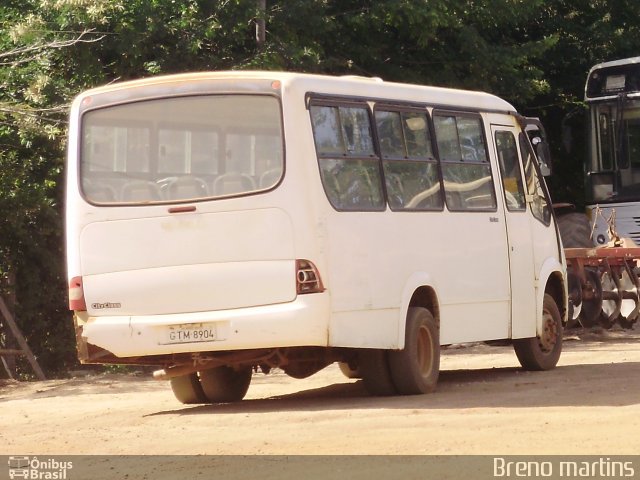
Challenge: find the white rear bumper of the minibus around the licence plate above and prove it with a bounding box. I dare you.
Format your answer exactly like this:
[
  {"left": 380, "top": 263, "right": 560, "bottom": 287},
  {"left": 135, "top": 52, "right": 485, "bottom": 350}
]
[{"left": 75, "top": 292, "right": 330, "bottom": 363}]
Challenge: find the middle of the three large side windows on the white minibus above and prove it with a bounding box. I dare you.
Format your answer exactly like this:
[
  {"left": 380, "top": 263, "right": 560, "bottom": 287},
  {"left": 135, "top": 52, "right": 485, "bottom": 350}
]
[{"left": 375, "top": 110, "right": 443, "bottom": 210}]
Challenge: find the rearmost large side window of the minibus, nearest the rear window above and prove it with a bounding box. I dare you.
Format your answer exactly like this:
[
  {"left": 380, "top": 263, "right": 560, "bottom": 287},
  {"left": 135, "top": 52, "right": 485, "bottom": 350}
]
[{"left": 310, "top": 105, "right": 385, "bottom": 211}]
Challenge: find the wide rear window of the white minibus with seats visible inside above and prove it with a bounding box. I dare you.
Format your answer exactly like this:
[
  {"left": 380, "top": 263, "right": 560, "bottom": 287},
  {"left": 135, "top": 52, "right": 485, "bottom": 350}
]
[{"left": 80, "top": 95, "right": 284, "bottom": 204}]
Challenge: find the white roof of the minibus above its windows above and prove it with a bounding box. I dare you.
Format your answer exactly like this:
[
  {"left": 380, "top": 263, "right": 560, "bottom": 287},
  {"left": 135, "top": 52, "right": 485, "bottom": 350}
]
[{"left": 75, "top": 70, "right": 516, "bottom": 113}]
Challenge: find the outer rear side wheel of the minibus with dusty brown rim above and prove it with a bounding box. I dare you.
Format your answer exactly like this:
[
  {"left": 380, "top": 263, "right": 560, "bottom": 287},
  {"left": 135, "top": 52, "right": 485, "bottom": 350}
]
[{"left": 389, "top": 307, "right": 440, "bottom": 395}]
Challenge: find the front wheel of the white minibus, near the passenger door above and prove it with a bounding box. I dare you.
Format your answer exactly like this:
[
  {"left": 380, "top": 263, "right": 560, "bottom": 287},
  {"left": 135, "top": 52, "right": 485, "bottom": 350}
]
[{"left": 513, "top": 293, "right": 562, "bottom": 371}]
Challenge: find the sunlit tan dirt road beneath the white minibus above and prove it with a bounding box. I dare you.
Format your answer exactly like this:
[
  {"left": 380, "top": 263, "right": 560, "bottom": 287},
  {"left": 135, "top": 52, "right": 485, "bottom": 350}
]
[{"left": 0, "top": 331, "right": 640, "bottom": 455}]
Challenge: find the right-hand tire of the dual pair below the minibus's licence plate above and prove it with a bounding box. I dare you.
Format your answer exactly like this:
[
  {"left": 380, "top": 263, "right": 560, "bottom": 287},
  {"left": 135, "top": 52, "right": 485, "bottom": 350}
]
[{"left": 199, "top": 366, "right": 252, "bottom": 403}]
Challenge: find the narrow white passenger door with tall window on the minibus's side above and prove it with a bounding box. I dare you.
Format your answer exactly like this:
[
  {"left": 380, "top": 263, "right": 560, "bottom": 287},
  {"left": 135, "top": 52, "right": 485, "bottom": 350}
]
[{"left": 491, "top": 124, "right": 537, "bottom": 338}]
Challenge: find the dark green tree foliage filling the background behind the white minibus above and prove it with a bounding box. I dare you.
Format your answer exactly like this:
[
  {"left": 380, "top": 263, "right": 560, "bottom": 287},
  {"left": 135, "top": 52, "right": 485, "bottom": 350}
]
[{"left": 0, "top": 0, "right": 640, "bottom": 372}]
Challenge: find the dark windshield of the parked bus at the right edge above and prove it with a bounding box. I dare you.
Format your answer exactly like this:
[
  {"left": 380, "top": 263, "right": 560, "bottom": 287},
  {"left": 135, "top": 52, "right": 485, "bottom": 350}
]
[{"left": 589, "top": 102, "right": 640, "bottom": 202}]
